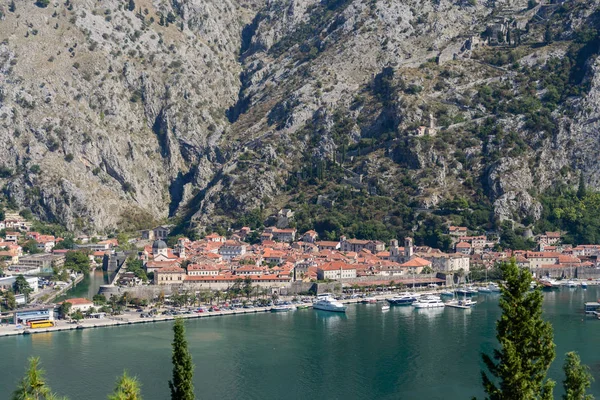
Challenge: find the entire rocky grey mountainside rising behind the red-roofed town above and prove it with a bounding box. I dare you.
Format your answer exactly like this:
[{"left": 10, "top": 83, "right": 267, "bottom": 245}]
[{"left": 0, "top": 0, "right": 600, "bottom": 239}]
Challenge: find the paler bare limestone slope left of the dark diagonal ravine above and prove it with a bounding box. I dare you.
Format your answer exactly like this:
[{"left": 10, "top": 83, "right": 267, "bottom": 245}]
[{"left": 0, "top": 0, "right": 251, "bottom": 229}]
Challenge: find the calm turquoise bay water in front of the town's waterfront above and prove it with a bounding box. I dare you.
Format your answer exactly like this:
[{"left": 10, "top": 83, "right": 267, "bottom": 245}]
[{"left": 0, "top": 288, "right": 600, "bottom": 400}]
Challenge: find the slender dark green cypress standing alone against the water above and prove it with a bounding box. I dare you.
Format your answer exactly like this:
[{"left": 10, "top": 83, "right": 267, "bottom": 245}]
[{"left": 169, "top": 318, "right": 194, "bottom": 400}]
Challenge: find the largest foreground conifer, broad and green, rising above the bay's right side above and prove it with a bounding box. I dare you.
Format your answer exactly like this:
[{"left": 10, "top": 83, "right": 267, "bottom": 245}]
[{"left": 481, "top": 259, "right": 555, "bottom": 400}]
